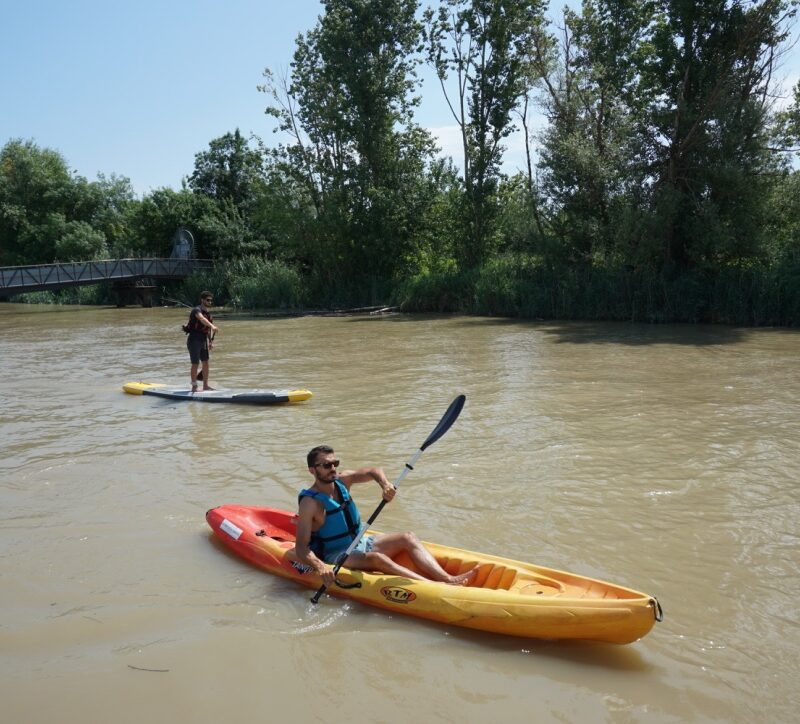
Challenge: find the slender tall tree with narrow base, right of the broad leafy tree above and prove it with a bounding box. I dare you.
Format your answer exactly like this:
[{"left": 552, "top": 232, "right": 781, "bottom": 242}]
[{"left": 425, "top": 0, "right": 545, "bottom": 267}]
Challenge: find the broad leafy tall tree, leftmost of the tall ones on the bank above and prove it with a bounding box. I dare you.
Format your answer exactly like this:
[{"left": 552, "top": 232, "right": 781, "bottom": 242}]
[{"left": 262, "top": 0, "right": 433, "bottom": 294}]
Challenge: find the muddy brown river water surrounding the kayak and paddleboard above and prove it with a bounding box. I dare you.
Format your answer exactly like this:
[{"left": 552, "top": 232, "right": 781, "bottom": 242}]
[{"left": 0, "top": 304, "right": 800, "bottom": 724}]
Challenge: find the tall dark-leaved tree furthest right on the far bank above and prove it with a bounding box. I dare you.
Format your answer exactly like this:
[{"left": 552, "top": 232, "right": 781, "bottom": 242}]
[{"left": 641, "top": 0, "right": 795, "bottom": 269}]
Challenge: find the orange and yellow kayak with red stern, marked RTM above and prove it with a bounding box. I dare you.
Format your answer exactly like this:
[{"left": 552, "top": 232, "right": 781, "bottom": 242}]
[{"left": 206, "top": 505, "right": 662, "bottom": 644}]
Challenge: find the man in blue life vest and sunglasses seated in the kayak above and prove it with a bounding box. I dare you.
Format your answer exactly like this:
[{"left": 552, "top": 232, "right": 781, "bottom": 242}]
[{"left": 295, "top": 445, "right": 478, "bottom": 586}]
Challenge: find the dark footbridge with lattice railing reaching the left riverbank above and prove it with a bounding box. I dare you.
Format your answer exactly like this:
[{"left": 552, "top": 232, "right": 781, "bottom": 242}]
[{"left": 0, "top": 259, "right": 214, "bottom": 296}]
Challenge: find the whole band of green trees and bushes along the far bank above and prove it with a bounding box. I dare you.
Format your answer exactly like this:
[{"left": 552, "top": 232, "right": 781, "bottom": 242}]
[{"left": 0, "top": 0, "right": 800, "bottom": 325}]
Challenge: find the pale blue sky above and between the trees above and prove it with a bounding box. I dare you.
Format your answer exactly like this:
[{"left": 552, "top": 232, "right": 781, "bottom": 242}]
[{"left": 0, "top": 0, "right": 800, "bottom": 195}]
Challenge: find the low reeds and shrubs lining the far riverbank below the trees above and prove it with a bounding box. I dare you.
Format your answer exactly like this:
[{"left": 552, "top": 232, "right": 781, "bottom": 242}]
[{"left": 12, "top": 252, "right": 800, "bottom": 327}]
